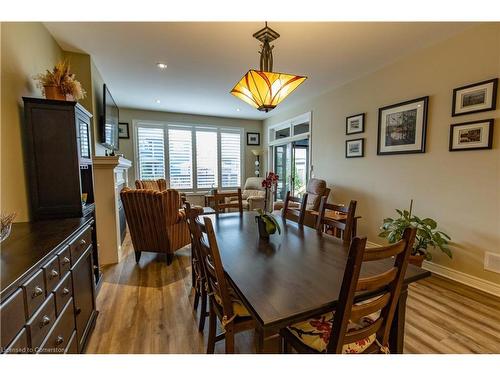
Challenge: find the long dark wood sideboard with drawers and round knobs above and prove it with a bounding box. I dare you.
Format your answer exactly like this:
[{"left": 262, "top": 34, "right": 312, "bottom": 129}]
[{"left": 0, "top": 217, "right": 98, "bottom": 354}]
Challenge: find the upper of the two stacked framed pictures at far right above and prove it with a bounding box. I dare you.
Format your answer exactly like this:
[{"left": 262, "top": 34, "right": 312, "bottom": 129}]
[{"left": 451, "top": 78, "right": 498, "bottom": 117}]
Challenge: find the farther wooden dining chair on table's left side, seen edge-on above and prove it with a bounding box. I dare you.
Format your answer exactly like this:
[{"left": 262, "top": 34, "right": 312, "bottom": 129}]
[{"left": 184, "top": 201, "right": 208, "bottom": 332}]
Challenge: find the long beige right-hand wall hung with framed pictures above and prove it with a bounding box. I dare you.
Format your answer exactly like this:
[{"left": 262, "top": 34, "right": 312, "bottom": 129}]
[{"left": 264, "top": 23, "right": 500, "bottom": 283}]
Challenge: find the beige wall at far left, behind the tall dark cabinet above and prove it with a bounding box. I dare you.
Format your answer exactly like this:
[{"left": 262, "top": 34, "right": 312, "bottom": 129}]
[{"left": 0, "top": 22, "right": 62, "bottom": 221}]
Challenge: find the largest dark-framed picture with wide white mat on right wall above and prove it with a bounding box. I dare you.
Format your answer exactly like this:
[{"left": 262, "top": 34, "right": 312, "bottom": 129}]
[{"left": 377, "top": 96, "right": 429, "bottom": 155}]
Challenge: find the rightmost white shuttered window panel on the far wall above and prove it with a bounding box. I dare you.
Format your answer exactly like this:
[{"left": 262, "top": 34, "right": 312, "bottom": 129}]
[{"left": 220, "top": 133, "right": 241, "bottom": 188}]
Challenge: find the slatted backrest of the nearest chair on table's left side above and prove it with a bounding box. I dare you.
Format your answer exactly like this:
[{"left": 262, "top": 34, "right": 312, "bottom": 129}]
[{"left": 195, "top": 217, "right": 233, "bottom": 319}]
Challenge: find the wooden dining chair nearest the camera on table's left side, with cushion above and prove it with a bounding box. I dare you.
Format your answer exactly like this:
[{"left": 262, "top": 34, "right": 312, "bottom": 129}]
[{"left": 195, "top": 217, "right": 255, "bottom": 354}]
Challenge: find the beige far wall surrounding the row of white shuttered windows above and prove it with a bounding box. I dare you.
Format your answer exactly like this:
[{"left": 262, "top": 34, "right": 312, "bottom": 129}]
[{"left": 118, "top": 108, "right": 262, "bottom": 188}]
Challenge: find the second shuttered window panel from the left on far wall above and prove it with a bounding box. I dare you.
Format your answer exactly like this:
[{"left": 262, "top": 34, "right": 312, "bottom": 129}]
[{"left": 168, "top": 129, "right": 193, "bottom": 189}]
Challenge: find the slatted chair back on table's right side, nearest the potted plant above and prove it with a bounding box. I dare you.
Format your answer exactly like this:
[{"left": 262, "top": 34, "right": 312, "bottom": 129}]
[{"left": 316, "top": 197, "right": 357, "bottom": 242}]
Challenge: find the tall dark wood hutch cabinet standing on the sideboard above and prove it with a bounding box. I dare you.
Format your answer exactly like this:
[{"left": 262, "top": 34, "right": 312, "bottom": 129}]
[{"left": 23, "top": 98, "right": 94, "bottom": 220}]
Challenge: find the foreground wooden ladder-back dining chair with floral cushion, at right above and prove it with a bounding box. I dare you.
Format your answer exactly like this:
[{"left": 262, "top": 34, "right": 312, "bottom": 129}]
[{"left": 280, "top": 228, "right": 416, "bottom": 354}]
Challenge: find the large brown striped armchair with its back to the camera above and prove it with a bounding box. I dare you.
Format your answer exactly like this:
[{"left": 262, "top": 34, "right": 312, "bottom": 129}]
[{"left": 120, "top": 188, "right": 191, "bottom": 264}]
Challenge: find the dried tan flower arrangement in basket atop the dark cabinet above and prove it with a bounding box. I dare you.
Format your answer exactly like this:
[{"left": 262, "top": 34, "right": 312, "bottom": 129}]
[{"left": 34, "top": 60, "right": 86, "bottom": 101}]
